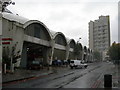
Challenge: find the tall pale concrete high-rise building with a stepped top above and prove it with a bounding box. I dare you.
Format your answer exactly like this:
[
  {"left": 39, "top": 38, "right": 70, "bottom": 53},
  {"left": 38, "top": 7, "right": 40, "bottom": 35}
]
[{"left": 89, "top": 16, "right": 110, "bottom": 60}]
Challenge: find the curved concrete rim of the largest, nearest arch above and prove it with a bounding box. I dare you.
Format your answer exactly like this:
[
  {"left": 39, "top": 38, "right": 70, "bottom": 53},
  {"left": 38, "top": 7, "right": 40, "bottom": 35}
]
[{"left": 23, "top": 20, "right": 52, "bottom": 39}]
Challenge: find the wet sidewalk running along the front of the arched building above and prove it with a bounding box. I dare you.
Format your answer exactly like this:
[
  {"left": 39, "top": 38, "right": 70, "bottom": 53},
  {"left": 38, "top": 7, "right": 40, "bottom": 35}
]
[{"left": 2, "top": 67, "right": 68, "bottom": 83}]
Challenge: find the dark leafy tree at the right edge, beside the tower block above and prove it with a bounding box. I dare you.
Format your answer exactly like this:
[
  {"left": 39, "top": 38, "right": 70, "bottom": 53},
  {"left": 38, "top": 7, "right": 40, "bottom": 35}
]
[{"left": 108, "top": 42, "right": 120, "bottom": 64}]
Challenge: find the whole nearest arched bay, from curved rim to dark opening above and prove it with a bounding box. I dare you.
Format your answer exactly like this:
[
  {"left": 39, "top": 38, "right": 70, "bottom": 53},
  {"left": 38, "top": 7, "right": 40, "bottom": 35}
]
[{"left": 21, "top": 20, "right": 52, "bottom": 67}]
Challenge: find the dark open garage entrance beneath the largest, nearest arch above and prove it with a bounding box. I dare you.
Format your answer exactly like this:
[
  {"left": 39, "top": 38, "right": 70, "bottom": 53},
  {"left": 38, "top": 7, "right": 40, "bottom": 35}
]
[{"left": 21, "top": 42, "right": 50, "bottom": 69}]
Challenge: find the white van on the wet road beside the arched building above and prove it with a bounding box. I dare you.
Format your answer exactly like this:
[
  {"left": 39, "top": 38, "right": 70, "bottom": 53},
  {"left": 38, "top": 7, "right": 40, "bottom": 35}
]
[{"left": 70, "top": 60, "right": 88, "bottom": 69}]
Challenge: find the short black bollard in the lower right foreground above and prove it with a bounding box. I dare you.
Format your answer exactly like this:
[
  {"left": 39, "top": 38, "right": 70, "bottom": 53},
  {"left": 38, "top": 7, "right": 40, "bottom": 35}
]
[{"left": 104, "top": 74, "right": 112, "bottom": 88}]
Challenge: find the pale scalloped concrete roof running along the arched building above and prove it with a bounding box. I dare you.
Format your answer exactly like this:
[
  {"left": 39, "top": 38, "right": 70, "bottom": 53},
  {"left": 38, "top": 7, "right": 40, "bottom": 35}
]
[{"left": 2, "top": 12, "right": 82, "bottom": 46}]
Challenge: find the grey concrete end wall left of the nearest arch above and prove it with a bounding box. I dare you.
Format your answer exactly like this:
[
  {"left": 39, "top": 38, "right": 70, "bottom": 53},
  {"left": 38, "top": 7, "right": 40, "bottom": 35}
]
[{"left": 3, "top": 18, "right": 24, "bottom": 66}]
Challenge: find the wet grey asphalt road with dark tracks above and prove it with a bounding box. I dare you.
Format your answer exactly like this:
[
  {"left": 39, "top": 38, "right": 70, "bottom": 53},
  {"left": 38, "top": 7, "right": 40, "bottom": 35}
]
[{"left": 3, "top": 62, "right": 113, "bottom": 88}]
